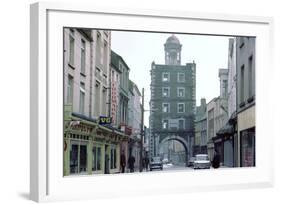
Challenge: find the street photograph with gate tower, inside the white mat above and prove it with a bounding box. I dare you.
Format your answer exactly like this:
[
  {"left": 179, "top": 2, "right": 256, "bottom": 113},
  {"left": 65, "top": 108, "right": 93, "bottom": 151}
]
[{"left": 63, "top": 28, "right": 256, "bottom": 176}]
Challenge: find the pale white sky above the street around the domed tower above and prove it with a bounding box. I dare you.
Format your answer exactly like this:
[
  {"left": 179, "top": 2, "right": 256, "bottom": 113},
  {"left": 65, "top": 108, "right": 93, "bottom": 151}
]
[{"left": 111, "top": 31, "right": 230, "bottom": 127}]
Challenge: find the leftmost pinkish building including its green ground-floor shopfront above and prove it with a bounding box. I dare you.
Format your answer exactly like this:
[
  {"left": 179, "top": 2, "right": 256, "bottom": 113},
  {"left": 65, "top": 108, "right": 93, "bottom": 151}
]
[{"left": 63, "top": 28, "right": 128, "bottom": 176}]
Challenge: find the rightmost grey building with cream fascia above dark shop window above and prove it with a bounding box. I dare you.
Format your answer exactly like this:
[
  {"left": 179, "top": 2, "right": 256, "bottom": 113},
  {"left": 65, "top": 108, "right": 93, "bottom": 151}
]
[{"left": 236, "top": 37, "right": 256, "bottom": 167}]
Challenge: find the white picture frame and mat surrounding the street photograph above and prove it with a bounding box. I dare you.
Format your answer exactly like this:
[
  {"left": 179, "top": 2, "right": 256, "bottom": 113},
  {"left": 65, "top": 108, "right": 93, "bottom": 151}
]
[{"left": 30, "top": 2, "right": 274, "bottom": 202}]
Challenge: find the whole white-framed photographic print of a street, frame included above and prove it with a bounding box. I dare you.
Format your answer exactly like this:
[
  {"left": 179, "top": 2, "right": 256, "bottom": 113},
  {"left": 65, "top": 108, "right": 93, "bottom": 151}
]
[{"left": 30, "top": 3, "right": 273, "bottom": 201}]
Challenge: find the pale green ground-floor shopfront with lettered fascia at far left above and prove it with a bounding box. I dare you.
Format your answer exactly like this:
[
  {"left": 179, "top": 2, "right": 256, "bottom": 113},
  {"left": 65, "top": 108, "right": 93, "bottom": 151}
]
[{"left": 63, "top": 114, "right": 128, "bottom": 176}]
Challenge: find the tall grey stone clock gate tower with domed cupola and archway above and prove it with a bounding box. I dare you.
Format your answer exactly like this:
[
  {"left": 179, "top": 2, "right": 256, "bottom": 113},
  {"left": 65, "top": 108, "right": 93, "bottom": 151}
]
[{"left": 150, "top": 35, "right": 196, "bottom": 163}]
